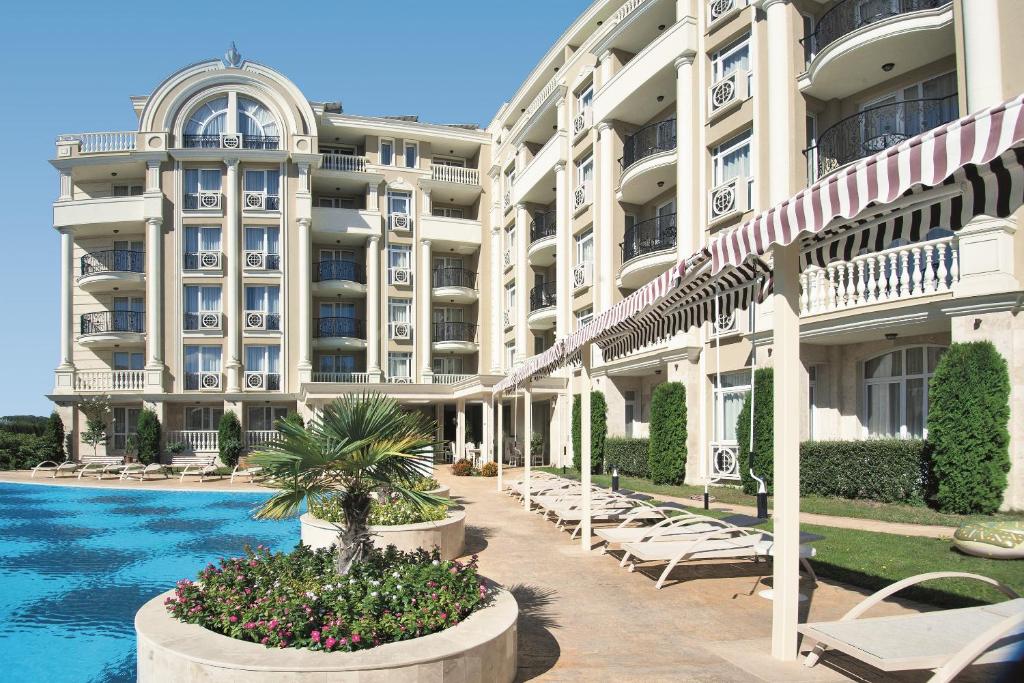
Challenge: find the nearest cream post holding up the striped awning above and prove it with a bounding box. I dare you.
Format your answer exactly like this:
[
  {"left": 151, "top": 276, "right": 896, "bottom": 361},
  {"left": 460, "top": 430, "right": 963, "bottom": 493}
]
[{"left": 771, "top": 242, "right": 803, "bottom": 660}]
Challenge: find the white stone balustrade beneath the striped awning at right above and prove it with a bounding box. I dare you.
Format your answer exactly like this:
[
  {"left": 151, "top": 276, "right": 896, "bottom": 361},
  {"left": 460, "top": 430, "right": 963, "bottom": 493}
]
[{"left": 800, "top": 237, "right": 959, "bottom": 315}]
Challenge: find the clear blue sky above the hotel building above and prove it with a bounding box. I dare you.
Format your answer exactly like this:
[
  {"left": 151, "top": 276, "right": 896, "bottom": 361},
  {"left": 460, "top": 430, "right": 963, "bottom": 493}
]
[{"left": 0, "top": 0, "right": 588, "bottom": 415}]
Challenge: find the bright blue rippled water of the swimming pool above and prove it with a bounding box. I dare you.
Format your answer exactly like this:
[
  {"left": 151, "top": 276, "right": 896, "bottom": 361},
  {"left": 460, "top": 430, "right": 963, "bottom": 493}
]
[{"left": 0, "top": 483, "right": 299, "bottom": 683}]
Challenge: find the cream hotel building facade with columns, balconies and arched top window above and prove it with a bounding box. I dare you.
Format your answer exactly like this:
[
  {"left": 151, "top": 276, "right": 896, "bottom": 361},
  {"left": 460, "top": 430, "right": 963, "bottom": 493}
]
[{"left": 53, "top": 0, "right": 1024, "bottom": 508}]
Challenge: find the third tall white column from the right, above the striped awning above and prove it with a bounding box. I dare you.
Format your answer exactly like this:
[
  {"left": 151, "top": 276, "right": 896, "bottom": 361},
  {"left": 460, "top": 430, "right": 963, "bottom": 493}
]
[{"left": 676, "top": 50, "right": 699, "bottom": 259}]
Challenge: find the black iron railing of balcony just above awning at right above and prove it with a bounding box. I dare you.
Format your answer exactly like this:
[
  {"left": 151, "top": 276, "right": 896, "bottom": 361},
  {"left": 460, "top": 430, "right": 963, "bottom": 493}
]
[{"left": 804, "top": 93, "right": 959, "bottom": 179}]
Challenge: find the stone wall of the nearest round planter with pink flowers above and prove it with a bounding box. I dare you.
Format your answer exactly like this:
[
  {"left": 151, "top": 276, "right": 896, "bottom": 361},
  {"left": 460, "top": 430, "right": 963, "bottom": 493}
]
[{"left": 135, "top": 588, "right": 519, "bottom": 683}]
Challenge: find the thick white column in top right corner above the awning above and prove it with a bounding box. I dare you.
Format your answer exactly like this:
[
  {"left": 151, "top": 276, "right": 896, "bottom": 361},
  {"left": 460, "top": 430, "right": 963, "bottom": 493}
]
[{"left": 961, "top": 0, "right": 1003, "bottom": 113}]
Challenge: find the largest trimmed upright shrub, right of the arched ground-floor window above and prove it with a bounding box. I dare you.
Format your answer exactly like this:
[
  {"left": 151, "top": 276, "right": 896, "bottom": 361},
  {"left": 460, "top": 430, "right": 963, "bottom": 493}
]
[{"left": 928, "top": 341, "right": 1010, "bottom": 514}]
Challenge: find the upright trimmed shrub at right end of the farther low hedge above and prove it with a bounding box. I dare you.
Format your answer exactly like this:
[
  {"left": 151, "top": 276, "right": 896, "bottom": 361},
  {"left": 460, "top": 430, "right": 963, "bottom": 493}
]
[{"left": 648, "top": 382, "right": 686, "bottom": 485}]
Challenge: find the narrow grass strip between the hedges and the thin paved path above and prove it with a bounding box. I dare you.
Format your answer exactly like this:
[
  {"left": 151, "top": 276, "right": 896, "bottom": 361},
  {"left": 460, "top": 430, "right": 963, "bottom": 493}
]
[{"left": 541, "top": 467, "right": 1024, "bottom": 526}]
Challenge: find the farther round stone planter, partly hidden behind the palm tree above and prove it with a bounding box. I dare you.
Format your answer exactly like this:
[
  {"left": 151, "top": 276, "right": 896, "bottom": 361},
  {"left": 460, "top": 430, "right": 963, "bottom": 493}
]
[{"left": 299, "top": 509, "right": 466, "bottom": 560}]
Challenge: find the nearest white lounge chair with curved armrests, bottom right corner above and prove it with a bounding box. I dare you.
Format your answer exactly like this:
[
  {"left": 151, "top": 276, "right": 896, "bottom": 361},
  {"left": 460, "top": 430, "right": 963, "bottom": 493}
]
[{"left": 797, "top": 571, "right": 1024, "bottom": 683}]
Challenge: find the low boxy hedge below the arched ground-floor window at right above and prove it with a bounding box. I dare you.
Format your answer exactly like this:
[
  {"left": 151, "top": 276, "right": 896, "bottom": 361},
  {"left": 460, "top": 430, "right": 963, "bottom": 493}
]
[{"left": 800, "top": 438, "right": 928, "bottom": 505}]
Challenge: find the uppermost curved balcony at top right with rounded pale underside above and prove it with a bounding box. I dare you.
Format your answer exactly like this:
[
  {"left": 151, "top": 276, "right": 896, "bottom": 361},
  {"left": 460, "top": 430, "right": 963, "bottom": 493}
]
[{"left": 799, "top": 0, "right": 956, "bottom": 100}]
